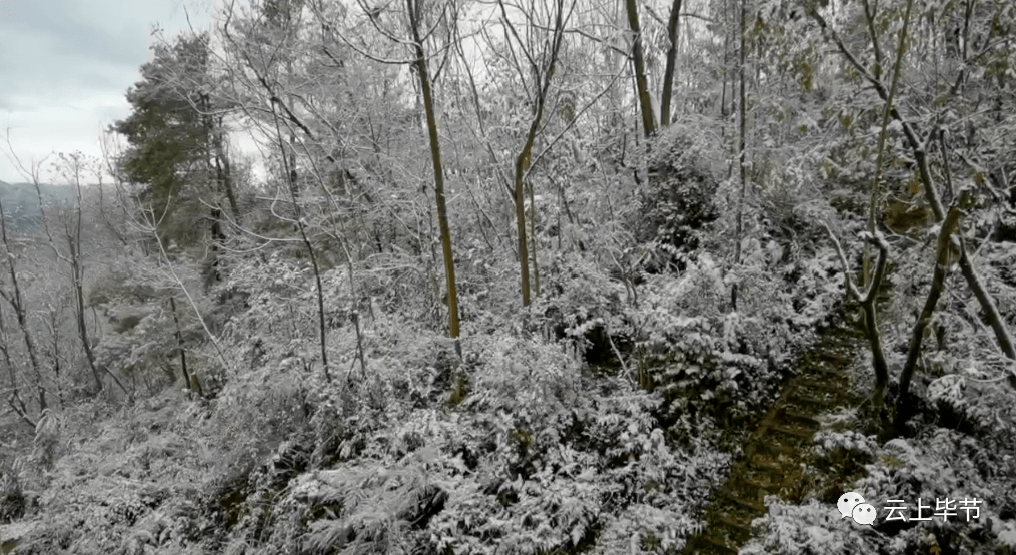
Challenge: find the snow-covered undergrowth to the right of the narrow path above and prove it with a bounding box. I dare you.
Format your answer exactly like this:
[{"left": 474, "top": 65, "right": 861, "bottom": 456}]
[{"left": 741, "top": 222, "right": 1016, "bottom": 555}]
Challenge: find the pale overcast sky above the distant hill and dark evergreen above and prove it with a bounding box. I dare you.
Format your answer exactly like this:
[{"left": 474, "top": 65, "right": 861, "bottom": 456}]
[{"left": 0, "top": 0, "right": 220, "bottom": 183}]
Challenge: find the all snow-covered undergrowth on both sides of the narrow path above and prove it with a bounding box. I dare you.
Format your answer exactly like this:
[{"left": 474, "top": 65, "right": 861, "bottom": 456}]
[{"left": 0, "top": 118, "right": 1016, "bottom": 555}]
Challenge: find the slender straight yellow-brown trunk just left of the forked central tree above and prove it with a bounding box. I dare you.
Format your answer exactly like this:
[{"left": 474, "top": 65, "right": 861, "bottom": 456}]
[{"left": 405, "top": 0, "right": 463, "bottom": 339}]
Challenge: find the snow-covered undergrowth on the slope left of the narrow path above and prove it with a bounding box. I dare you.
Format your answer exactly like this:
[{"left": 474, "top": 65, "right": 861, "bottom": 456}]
[{"left": 4, "top": 126, "right": 842, "bottom": 555}]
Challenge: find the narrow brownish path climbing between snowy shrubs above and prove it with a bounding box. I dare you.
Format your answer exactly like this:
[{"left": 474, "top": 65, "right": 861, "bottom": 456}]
[{"left": 683, "top": 323, "right": 866, "bottom": 555}]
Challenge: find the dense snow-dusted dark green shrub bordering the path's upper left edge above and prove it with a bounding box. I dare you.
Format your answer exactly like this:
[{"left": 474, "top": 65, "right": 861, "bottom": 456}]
[{"left": 635, "top": 254, "right": 828, "bottom": 443}]
